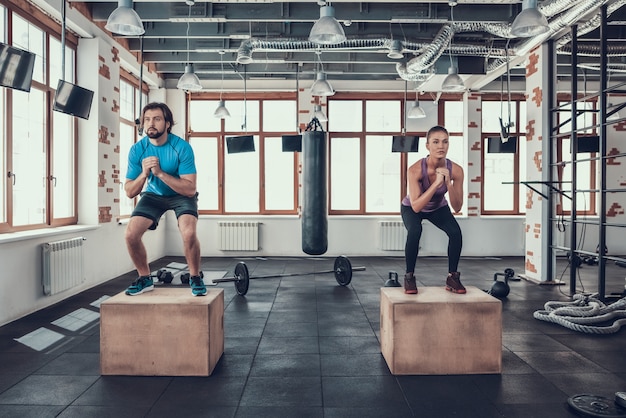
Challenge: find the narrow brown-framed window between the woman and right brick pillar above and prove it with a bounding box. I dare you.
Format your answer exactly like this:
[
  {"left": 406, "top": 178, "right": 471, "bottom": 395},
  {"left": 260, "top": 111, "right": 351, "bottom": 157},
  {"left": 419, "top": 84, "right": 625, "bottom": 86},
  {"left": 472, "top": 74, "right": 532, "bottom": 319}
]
[{"left": 481, "top": 97, "right": 527, "bottom": 215}]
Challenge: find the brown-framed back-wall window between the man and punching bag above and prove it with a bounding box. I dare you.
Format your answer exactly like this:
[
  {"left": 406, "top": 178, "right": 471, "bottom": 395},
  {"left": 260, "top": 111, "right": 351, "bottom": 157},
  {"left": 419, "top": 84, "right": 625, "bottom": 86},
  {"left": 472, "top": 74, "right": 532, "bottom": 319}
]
[{"left": 188, "top": 94, "right": 298, "bottom": 214}]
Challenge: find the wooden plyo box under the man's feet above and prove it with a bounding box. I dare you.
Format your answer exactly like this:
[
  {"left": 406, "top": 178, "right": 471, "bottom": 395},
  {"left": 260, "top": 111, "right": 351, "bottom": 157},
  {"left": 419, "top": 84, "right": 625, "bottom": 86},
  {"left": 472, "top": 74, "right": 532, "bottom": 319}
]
[{"left": 100, "top": 287, "right": 224, "bottom": 376}]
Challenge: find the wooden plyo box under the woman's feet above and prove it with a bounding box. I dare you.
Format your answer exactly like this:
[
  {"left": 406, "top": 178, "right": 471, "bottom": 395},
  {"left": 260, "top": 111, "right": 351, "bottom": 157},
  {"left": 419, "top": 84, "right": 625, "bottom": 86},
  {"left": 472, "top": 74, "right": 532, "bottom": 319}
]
[{"left": 380, "top": 286, "right": 502, "bottom": 375}]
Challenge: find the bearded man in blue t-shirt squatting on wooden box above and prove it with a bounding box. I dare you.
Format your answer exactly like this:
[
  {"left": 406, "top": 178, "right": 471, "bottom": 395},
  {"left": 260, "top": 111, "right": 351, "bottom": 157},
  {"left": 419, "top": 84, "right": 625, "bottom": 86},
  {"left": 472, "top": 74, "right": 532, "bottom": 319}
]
[{"left": 124, "top": 103, "right": 207, "bottom": 296}]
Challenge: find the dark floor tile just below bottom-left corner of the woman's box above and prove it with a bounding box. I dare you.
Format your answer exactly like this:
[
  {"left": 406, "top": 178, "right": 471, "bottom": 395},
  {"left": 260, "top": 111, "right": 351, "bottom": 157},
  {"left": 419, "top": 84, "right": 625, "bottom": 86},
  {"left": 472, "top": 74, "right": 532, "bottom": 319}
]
[{"left": 322, "top": 376, "right": 406, "bottom": 410}]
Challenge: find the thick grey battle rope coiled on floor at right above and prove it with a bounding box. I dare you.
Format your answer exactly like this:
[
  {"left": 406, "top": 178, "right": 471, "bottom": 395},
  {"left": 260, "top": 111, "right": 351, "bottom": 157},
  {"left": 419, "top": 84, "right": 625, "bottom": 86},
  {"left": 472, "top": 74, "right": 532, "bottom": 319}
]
[{"left": 533, "top": 293, "right": 626, "bottom": 334}]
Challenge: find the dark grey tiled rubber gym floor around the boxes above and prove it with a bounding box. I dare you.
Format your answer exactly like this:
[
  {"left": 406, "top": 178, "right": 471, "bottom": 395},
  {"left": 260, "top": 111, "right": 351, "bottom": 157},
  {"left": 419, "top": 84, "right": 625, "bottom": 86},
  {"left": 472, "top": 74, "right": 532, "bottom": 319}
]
[{"left": 0, "top": 257, "right": 626, "bottom": 418}]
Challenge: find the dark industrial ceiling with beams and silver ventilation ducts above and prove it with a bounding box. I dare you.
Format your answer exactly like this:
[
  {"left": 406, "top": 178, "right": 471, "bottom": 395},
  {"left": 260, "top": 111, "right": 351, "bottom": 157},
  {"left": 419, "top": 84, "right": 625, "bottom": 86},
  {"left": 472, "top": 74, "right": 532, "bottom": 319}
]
[{"left": 64, "top": 0, "right": 626, "bottom": 91}]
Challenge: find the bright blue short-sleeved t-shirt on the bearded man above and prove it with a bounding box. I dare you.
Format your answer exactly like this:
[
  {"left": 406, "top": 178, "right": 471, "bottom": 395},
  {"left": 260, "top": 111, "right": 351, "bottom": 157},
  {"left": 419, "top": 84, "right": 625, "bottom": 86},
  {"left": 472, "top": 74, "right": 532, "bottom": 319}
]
[{"left": 126, "top": 133, "right": 196, "bottom": 196}]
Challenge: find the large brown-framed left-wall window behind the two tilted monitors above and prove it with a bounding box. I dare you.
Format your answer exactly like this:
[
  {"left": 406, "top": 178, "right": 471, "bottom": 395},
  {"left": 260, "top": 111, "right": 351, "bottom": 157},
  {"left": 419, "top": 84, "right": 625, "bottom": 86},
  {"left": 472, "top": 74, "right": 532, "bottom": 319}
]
[{"left": 0, "top": 7, "right": 78, "bottom": 232}]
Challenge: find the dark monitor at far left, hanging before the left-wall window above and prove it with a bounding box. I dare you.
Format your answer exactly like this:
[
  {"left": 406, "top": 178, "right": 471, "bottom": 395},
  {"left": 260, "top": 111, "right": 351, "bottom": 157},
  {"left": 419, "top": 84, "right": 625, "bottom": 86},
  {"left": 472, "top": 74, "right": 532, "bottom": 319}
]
[{"left": 0, "top": 42, "right": 35, "bottom": 92}]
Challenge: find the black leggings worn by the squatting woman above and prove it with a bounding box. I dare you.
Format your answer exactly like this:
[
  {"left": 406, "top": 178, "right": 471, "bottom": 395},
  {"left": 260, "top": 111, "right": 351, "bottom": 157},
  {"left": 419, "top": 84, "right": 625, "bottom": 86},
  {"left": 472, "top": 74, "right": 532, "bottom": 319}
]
[{"left": 400, "top": 205, "right": 463, "bottom": 273}]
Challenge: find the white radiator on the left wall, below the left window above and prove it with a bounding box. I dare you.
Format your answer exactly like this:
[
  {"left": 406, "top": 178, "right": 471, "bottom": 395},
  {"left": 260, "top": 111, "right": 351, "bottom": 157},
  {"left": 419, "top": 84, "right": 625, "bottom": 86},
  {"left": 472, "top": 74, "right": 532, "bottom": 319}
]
[{"left": 42, "top": 237, "right": 85, "bottom": 296}]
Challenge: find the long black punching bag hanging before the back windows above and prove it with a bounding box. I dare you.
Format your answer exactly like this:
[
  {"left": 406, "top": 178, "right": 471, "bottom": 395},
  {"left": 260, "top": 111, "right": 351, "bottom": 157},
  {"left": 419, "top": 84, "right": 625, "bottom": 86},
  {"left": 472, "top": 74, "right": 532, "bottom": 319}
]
[{"left": 302, "top": 131, "right": 328, "bottom": 255}]
